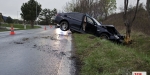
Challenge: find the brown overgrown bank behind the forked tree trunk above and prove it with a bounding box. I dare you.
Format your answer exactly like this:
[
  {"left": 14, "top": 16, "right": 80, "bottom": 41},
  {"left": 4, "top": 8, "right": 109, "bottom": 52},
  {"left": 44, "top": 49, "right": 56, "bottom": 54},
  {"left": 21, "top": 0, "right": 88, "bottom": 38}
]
[{"left": 103, "top": 6, "right": 150, "bottom": 35}]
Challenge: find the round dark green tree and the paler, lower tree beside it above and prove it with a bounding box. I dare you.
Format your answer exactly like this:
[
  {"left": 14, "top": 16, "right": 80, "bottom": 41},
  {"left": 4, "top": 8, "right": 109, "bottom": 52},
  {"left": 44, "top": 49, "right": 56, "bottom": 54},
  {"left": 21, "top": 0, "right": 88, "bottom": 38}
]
[{"left": 20, "top": 0, "right": 57, "bottom": 28}]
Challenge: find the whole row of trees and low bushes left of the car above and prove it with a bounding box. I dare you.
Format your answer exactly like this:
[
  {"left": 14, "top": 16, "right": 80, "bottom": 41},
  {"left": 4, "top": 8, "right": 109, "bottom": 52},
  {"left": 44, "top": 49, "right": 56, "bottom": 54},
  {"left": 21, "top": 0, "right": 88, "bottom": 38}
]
[{"left": 0, "top": 0, "right": 57, "bottom": 28}]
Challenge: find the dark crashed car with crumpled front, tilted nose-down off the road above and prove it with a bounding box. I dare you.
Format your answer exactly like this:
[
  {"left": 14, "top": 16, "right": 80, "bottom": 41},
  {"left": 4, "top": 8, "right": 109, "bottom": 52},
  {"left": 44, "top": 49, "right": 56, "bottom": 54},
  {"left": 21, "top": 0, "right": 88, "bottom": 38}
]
[{"left": 54, "top": 12, "right": 124, "bottom": 42}]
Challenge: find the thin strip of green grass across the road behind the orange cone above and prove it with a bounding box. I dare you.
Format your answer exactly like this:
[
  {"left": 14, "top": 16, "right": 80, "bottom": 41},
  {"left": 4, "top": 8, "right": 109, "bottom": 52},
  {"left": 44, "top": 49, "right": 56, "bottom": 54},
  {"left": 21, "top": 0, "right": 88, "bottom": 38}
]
[{"left": 0, "top": 24, "right": 41, "bottom": 31}]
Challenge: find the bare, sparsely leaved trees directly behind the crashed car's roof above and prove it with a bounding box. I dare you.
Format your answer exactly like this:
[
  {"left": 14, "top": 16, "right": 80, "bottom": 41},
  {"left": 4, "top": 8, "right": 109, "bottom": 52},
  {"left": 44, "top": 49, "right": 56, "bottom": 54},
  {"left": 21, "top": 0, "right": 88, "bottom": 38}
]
[{"left": 64, "top": 0, "right": 117, "bottom": 20}]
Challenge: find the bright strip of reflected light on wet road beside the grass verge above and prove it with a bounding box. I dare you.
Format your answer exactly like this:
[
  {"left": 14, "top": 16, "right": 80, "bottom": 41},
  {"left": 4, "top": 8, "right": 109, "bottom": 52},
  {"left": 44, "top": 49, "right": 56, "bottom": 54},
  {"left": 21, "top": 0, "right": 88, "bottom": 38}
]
[{"left": 53, "top": 29, "right": 76, "bottom": 75}]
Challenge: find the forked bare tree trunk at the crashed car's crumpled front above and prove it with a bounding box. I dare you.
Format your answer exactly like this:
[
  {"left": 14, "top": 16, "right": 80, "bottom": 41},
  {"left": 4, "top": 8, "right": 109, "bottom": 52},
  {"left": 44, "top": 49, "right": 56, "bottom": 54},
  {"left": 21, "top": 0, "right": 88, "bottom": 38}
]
[{"left": 123, "top": 0, "right": 139, "bottom": 44}]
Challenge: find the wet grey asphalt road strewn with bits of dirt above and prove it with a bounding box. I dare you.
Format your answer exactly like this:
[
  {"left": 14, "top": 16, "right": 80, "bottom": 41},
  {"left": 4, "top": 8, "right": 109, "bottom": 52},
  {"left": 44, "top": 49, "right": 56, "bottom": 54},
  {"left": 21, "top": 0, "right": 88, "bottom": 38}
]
[{"left": 0, "top": 26, "right": 75, "bottom": 75}]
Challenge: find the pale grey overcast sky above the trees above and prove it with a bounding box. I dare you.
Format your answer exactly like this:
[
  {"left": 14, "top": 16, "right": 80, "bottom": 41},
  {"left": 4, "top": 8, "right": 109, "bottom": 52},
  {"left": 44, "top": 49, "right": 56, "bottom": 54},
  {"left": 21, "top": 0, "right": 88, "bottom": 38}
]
[{"left": 0, "top": 0, "right": 146, "bottom": 19}]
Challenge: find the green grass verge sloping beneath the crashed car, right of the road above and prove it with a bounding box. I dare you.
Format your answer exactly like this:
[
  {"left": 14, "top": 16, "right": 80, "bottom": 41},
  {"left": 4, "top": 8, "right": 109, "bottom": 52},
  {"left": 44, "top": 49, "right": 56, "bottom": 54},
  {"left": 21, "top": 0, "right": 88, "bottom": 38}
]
[{"left": 73, "top": 34, "right": 150, "bottom": 75}]
